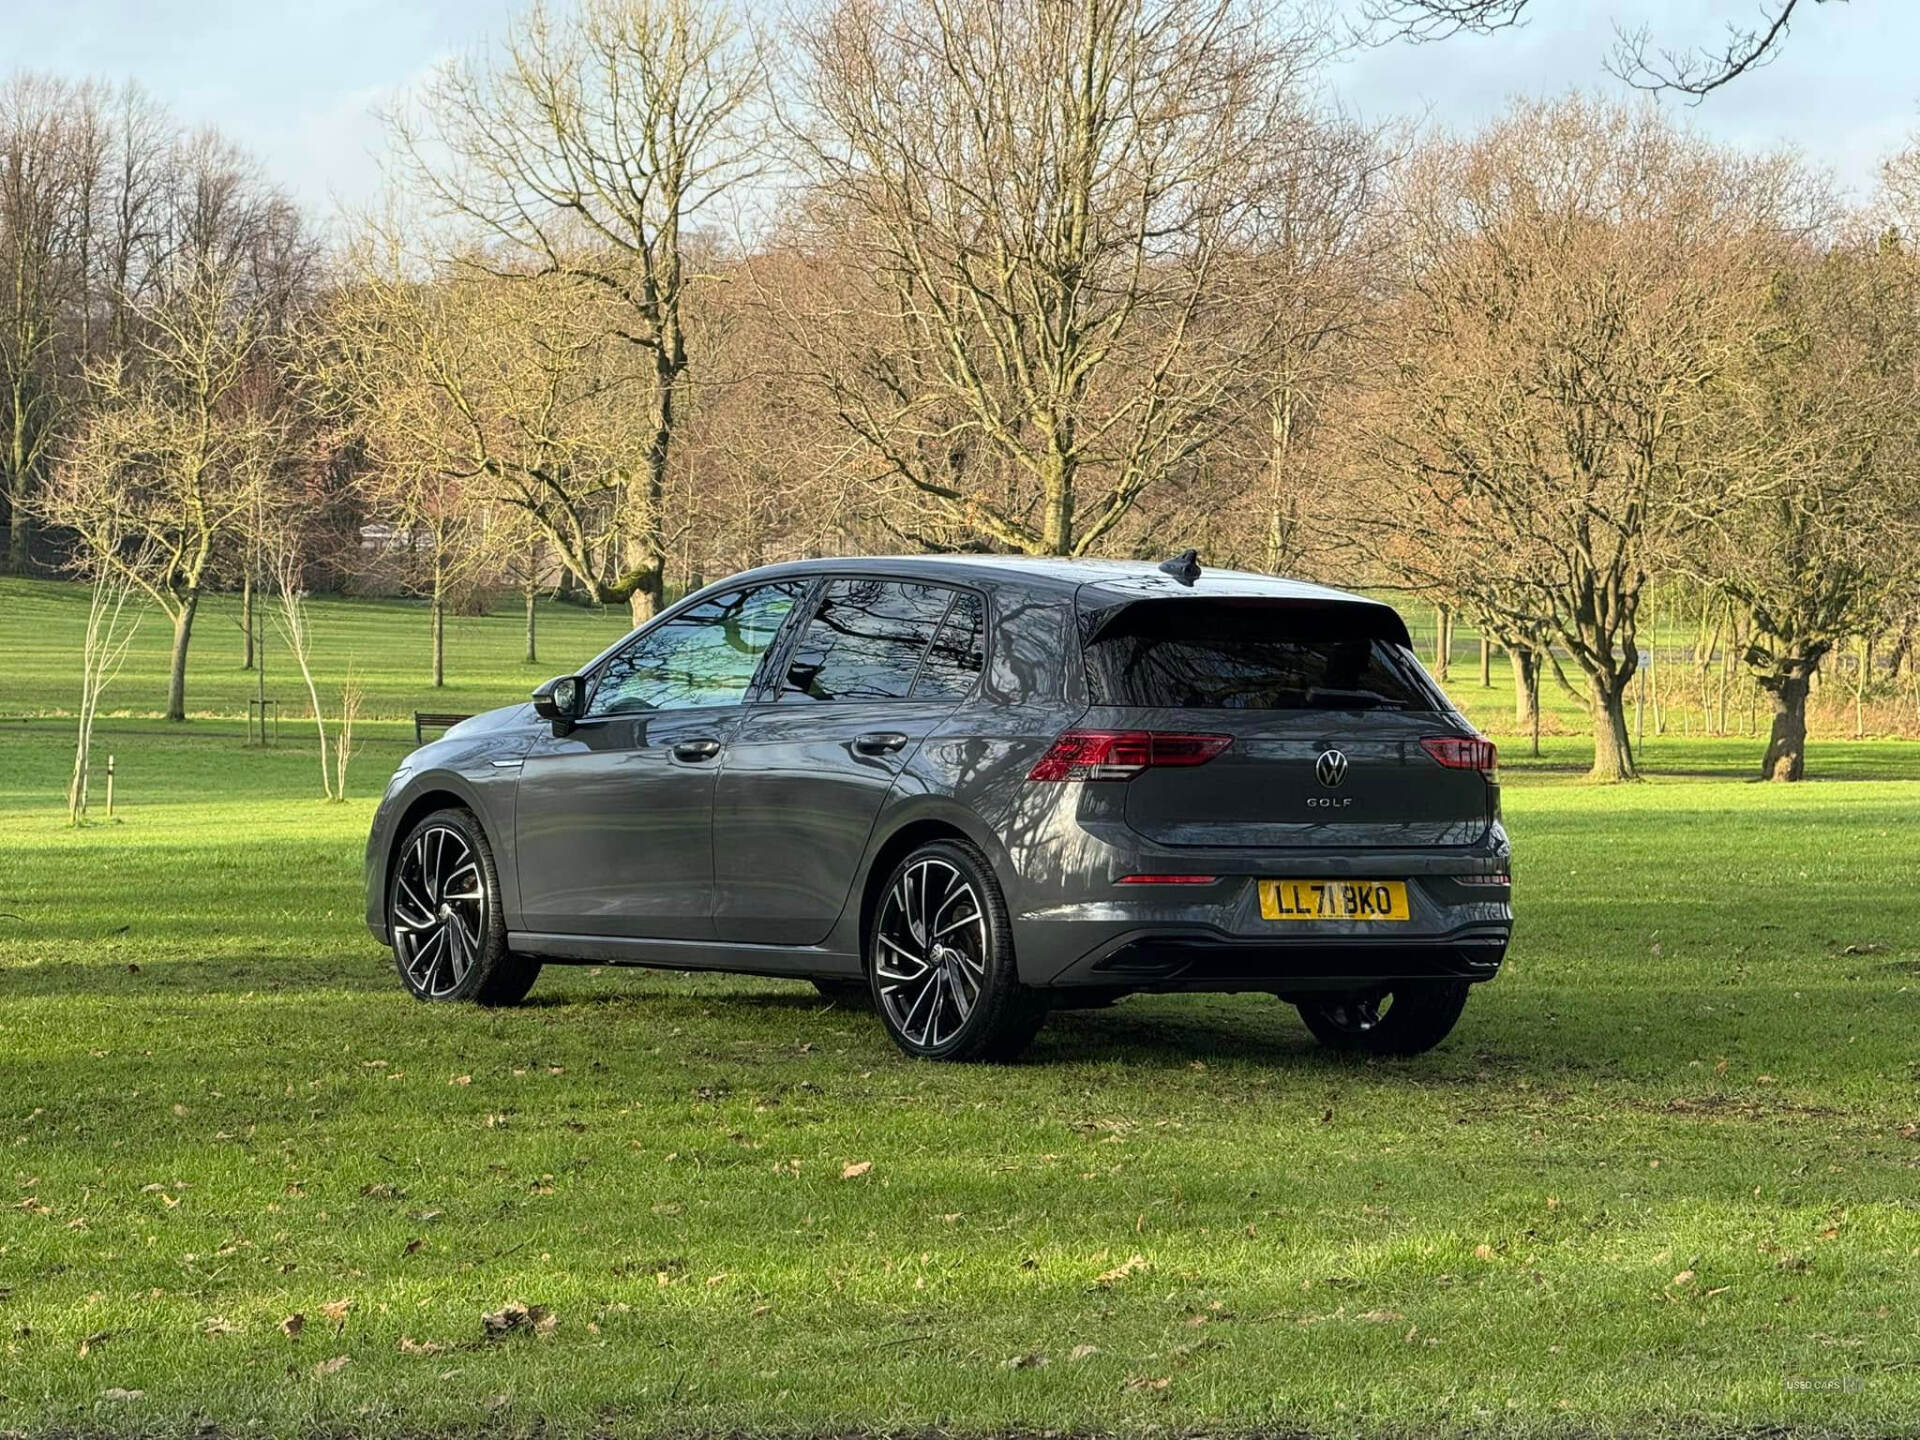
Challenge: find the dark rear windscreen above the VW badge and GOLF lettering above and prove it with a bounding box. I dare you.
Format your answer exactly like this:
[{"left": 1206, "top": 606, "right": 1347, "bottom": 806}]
[{"left": 1085, "top": 599, "right": 1452, "bottom": 710}]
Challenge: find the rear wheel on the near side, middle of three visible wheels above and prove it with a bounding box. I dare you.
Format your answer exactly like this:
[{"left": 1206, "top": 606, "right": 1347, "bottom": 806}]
[{"left": 868, "top": 839, "right": 1046, "bottom": 1062}]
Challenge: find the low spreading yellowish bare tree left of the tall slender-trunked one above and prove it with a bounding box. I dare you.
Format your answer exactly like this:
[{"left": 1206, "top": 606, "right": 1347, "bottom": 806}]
[{"left": 311, "top": 223, "right": 648, "bottom": 629}]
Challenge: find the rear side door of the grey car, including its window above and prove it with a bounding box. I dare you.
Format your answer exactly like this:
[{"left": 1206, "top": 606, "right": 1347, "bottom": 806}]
[{"left": 714, "top": 578, "right": 987, "bottom": 945}]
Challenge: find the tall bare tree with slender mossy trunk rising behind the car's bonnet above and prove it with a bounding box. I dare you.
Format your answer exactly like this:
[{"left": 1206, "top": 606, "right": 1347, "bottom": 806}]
[{"left": 394, "top": 0, "right": 764, "bottom": 624}]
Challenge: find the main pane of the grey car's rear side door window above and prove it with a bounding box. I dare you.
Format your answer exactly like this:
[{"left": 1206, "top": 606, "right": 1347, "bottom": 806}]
[{"left": 781, "top": 580, "right": 954, "bottom": 701}]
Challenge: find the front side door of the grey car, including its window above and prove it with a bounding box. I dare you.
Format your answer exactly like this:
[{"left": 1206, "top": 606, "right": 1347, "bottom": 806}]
[{"left": 515, "top": 582, "right": 804, "bottom": 939}]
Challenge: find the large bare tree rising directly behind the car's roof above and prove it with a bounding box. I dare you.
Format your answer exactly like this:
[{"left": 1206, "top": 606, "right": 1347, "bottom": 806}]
[{"left": 797, "top": 0, "right": 1317, "bottom": 555}]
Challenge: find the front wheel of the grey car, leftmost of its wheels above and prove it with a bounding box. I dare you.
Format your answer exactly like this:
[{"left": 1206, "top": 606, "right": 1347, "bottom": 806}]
[{"left": 386, "top": 808, "right": 540, "bottom": 1006}]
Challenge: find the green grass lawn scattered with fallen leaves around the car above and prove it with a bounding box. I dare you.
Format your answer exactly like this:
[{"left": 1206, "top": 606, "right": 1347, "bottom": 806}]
[{"left": 0, "top": 586, "right": 1920, "bottom": 1436}]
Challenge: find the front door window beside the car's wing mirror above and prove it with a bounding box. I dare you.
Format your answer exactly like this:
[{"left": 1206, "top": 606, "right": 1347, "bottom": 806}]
[{"left": 588, "top": 584, "right": 801, "bottom": 716}]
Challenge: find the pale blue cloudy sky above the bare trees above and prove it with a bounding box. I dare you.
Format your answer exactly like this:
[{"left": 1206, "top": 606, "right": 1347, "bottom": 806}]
[{"left": 0, "top": 0, "right": 1920, "bottom": 215}]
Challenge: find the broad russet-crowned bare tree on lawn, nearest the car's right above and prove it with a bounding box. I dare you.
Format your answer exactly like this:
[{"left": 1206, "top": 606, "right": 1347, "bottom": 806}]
[{"left": 1356, "top": 100, "right": 1795, "bottom": 780}]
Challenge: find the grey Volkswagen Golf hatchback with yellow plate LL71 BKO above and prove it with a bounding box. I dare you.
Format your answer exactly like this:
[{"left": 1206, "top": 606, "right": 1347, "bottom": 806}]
[{"left": 367, "top": 551, "right": 1513, "bottom": 1060}]
